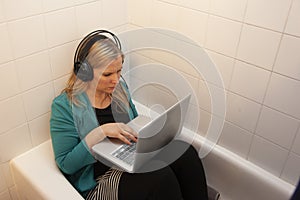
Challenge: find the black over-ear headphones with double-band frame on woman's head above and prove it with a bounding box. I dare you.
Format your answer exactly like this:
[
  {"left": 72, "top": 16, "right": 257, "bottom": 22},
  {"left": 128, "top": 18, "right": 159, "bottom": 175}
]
[{"left": 74, "top": 30, "right": 121, "bottom": 82}]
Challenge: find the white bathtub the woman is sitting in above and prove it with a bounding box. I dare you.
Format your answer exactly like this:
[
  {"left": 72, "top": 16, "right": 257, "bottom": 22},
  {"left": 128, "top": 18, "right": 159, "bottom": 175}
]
[{"left": 10, "top": 103, "right": 295, "bottom": 200}]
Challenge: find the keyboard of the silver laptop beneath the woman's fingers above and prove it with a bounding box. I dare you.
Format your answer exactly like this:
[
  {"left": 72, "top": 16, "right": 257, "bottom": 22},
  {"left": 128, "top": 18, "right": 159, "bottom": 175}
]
[{"left": 111, "top": 142, "right": 136, "bottom": 165}]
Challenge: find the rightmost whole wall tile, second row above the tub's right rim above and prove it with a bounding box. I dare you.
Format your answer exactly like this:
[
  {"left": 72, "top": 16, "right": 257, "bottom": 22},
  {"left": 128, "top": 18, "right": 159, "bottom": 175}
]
[{"left": 256, "top": 107, "right": 299, "bottom": 149}]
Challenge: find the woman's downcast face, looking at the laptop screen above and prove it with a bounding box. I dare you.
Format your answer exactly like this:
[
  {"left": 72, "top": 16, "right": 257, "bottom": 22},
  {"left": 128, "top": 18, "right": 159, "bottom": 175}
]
[{"left": 94, "top": 56, "right": 122, "bottom": 94}]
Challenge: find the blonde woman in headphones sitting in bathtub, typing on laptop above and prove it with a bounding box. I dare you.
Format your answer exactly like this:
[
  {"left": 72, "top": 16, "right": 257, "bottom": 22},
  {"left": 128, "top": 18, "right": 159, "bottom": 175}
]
[{"left": 50, "top": 30, "right": 207, "bottom": 200}]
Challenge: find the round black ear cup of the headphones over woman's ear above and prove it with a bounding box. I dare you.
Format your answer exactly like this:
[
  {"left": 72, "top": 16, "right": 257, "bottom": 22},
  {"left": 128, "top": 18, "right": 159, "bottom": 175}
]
[{"left": 74, "top": 62, "right": 94, "bottom": 82}]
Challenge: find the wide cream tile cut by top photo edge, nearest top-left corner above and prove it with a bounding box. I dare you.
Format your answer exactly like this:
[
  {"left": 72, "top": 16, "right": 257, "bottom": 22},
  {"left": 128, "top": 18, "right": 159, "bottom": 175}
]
[{"left": 3, "top": 0, "right": 43, "bottom": 21}]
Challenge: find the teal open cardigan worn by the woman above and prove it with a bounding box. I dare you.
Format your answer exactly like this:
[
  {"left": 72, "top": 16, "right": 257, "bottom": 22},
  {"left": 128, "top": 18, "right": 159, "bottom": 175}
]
[{"left": 50, "top": 82, "right": 138, "bottom": 197}]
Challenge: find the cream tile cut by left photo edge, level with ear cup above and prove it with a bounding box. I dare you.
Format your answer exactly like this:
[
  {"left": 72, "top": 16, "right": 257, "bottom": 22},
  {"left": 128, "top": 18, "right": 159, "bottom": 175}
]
[{"left": 0, "top": 62, "right": 20, "bottom": 100}]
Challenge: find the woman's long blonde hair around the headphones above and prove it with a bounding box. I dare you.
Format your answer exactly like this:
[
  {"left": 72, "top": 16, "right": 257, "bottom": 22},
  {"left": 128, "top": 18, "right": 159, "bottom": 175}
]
[{"left": 62, "top": 38, "right": 129, "bottom": 108}]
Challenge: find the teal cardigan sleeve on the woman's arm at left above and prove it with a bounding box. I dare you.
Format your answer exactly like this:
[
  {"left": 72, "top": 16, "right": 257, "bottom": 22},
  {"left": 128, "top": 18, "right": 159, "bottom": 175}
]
[{"left": 50, "top": 94, "right": 96, "bottom": 174}]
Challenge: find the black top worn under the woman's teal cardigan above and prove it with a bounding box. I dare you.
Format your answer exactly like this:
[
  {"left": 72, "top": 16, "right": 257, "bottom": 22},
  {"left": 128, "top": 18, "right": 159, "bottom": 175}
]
[{"left": 94, "top": 104, "right": 130, "bottom": 179}]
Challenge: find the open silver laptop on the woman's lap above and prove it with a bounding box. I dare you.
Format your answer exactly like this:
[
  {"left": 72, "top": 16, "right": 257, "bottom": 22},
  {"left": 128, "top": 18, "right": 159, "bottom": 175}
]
[{"left": 92, "top": 94, "right": 191, "bottom": 173}]
